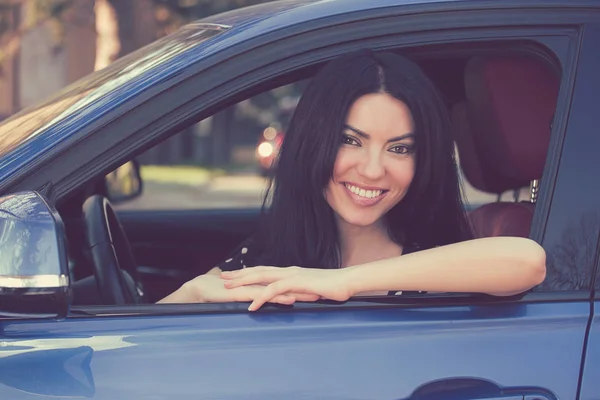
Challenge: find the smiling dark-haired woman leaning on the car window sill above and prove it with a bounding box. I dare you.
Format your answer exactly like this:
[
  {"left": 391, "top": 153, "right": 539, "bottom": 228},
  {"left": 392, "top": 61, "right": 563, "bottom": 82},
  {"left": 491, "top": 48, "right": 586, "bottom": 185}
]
[{"left": 162, "top": 50, "right": 545, "bottom": 310}]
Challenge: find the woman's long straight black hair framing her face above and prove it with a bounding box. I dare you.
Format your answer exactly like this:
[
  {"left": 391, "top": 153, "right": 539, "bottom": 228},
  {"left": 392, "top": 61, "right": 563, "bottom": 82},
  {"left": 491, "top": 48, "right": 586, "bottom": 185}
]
[{"left": 246, "top": 50, "right": 471, "bottom": 268}]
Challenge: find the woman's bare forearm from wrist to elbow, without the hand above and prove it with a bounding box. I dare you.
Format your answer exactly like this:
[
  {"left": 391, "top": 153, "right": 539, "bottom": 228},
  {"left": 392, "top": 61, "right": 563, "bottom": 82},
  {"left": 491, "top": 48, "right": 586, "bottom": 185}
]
[{"left": 345, "top": 237, "right": 546, "bottom": 296}]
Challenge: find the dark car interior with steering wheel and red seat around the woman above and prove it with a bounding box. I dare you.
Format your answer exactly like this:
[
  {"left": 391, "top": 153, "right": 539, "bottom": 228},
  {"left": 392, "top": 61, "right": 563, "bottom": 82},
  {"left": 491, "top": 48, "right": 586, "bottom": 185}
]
[{"left": 52, "top": 42, "right": 561, "bottom": 305}]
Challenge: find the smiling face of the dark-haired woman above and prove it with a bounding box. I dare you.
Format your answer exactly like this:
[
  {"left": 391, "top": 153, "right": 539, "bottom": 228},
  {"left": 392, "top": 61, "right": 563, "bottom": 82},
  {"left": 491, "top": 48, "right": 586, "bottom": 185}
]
[{"left": 325, "top": 93, "right": 415, "bottom": 226}]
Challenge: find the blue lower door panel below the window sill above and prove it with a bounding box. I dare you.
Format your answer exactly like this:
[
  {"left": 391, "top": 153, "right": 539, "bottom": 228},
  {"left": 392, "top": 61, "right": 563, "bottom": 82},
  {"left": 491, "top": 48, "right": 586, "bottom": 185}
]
[{"left": 0, "top": 302, "right": 597, "bottom": 400}]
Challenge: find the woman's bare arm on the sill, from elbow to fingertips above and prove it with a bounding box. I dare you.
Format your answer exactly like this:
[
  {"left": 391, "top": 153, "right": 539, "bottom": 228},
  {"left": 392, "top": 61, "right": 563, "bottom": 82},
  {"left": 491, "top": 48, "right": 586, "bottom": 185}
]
[{"left": 222, "top": 237, "right": 546, "bottom": 310}]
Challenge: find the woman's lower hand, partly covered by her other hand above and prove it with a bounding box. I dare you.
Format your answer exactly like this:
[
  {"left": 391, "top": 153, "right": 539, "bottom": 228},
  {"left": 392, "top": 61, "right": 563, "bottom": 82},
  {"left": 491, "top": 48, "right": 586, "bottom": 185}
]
[{"left": 159, "top": 274, "right": 319, "bottom": 305}]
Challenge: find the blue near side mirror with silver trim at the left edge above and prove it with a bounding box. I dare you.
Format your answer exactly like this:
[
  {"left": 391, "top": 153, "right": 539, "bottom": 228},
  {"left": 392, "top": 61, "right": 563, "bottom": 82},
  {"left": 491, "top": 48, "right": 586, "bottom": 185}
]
[{"left": 0, "top": 192, "right": 69, "bottom": 318}]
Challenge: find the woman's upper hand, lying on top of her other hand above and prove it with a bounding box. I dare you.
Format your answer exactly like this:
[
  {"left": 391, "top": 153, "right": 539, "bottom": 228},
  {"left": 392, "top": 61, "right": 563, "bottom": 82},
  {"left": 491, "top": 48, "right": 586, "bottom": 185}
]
[{"left": 221, "top": 267, "right": 352, "bottom": 311}]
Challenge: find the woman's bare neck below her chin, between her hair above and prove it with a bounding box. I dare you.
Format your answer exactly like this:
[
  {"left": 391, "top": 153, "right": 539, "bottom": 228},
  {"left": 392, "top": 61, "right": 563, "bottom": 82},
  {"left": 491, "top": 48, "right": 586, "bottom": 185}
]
[{"left": 338, "top": 218, "right": 402, "bottom": 267}]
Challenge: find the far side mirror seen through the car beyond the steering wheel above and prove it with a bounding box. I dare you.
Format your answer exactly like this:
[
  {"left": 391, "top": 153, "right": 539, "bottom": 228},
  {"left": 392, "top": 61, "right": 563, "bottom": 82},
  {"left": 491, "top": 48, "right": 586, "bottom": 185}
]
[{"left": 104, "top": 160, "right": 142, "bottom": 204}]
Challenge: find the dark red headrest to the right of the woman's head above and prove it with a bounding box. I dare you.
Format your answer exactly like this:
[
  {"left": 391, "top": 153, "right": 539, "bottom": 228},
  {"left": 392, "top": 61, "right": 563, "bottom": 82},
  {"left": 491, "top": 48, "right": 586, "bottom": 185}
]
[{"left": 453, "top": 56, "right": 560, "bottom": 193}]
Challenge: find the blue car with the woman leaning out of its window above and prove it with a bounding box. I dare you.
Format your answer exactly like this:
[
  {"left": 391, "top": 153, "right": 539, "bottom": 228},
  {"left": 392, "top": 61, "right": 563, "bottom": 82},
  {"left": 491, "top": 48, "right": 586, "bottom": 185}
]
[{"left": 0, "top": 0, "right": 600, "bottom": 400}]
